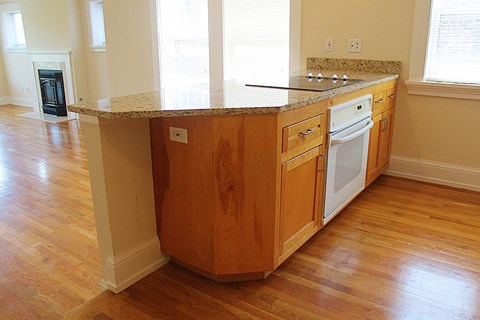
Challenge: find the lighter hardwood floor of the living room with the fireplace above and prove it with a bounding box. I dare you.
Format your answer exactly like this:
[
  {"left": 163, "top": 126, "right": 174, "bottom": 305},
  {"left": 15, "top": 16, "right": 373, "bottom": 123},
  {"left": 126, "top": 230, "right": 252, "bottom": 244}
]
[{"left": 0, "top": 106, "right": 102, "bottom": 320}]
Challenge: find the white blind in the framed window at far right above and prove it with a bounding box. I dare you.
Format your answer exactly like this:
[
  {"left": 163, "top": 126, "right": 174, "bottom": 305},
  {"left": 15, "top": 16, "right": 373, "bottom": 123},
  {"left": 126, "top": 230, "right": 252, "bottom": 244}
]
[{"left": 425, "top": 0, "right": 480, "bottom": 84}]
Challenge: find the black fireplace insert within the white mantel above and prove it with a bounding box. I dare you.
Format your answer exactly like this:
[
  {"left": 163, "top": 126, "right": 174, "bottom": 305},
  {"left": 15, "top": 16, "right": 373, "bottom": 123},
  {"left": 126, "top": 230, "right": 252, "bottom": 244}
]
[{"left": 38, "top": 69, "right": 67, "bottom": 116}]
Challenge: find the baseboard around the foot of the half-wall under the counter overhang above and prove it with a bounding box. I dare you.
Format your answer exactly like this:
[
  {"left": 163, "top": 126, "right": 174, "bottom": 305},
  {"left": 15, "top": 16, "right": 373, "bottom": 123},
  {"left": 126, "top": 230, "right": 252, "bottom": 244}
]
[{"left": 100, "top": 238, "right": 170, "bottom": 293}]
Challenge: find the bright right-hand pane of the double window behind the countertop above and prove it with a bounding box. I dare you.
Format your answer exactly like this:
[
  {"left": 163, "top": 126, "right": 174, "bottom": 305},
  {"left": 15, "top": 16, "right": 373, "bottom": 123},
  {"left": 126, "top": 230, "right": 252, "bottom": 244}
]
[{"left": 223, "top": 0, "right": 290, "bottom": 82}]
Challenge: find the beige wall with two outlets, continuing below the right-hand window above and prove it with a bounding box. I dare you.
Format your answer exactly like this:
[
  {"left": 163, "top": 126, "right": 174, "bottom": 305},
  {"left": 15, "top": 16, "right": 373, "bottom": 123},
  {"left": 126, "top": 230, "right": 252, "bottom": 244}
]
[{"left": 302, "top": 0, "right": 480, "bottom": 168}]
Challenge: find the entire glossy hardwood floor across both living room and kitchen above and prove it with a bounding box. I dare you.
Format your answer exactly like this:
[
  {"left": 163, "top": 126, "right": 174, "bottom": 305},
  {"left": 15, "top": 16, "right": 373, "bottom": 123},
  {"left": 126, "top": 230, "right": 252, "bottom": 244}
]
[{"left": 0, "top": 106, "right": 480, "bottom": 320}]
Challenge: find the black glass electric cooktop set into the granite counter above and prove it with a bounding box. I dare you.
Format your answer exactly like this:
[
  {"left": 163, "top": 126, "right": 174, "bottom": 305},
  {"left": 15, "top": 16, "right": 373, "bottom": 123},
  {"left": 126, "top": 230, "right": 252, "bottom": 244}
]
[{"left": 245, "top": 76, "right": 363, "bottom": 92}]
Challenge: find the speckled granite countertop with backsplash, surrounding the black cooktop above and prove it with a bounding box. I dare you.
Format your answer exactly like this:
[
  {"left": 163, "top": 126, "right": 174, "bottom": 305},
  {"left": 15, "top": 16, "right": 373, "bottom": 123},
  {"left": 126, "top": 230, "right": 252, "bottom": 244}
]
[{"left": 68, "top": 59, "right": 400, "bottom": 119}]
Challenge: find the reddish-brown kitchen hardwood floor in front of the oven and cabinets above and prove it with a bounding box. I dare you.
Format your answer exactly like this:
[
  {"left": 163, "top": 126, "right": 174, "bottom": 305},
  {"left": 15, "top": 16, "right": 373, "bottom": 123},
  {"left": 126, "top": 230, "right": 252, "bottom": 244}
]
[{"left": 67, "top": 176, "right": 480, "bottom": 320}]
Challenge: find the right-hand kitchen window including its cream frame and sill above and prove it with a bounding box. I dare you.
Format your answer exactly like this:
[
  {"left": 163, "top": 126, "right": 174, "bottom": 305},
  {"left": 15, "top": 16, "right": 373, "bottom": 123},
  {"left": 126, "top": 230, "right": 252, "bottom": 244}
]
[{"left": 405, "top": 0, "right": 480, "bottom": 100}]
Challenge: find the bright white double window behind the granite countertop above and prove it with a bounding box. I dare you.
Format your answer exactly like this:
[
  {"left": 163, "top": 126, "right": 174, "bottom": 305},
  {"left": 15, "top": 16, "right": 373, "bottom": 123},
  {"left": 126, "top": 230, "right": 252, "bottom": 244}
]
[{"left": 158, "top": 0, "right": 301, "bottom": 88}]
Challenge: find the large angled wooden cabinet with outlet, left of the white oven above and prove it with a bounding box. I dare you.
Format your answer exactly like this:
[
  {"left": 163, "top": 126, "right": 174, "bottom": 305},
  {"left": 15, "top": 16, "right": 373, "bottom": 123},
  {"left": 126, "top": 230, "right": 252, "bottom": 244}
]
[{"left": 150, "top": 100, "right": 328, "bottom": 282}]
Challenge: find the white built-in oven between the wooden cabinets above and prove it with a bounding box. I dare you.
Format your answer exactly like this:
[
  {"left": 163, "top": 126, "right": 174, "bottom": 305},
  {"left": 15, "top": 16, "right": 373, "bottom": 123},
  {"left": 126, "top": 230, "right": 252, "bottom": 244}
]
[{"left": 323, "top": 95, "right": 373, "bottom": 224}]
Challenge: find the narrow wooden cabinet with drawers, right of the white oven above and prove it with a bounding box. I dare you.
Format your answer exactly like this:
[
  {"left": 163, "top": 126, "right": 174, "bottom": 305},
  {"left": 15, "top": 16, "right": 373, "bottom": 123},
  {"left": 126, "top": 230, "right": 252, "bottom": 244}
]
[{"left": 365, "top": 80, "right": 397, "bottom": 186}]
